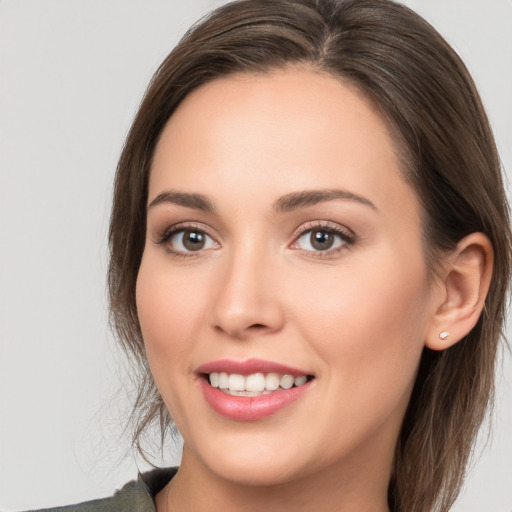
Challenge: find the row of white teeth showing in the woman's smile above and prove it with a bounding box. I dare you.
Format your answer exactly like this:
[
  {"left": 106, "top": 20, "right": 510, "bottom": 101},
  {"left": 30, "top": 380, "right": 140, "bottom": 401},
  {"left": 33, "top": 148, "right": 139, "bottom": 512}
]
[{"left": 209, "top": 372, "right": 308, "bottom": 396}]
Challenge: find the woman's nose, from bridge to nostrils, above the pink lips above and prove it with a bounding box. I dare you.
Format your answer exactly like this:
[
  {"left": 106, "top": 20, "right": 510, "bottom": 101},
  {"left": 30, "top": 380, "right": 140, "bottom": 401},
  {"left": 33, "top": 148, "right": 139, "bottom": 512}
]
[{"left": 211, "top": 251, "right": 284, "bottom": 339}]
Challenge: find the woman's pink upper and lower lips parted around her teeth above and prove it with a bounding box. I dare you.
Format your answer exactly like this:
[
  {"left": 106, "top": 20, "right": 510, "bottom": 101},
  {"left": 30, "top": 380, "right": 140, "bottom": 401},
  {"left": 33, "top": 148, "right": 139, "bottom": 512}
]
[{"left": 196, "top": 359, "right": 312, "bottom": 421}]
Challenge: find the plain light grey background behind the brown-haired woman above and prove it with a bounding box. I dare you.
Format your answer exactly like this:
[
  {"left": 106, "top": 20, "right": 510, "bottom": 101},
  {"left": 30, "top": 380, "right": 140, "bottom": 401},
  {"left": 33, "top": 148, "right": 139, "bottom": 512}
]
[{"left": 0, "top": 0, "right": 512, "bottom": 512}]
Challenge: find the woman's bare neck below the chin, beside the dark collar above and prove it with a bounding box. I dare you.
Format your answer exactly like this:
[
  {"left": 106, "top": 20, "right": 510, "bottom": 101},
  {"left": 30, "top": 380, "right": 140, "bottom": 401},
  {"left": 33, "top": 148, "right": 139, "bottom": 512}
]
[{"left": 156, "top": 446, "right": 391, "bottom": 512}]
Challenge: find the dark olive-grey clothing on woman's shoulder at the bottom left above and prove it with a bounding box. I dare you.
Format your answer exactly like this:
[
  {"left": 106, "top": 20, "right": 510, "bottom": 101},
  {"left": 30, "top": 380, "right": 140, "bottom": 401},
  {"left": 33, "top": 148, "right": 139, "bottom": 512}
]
[{"left": 25, "top": 468, "right": 177, "bottom": 512}]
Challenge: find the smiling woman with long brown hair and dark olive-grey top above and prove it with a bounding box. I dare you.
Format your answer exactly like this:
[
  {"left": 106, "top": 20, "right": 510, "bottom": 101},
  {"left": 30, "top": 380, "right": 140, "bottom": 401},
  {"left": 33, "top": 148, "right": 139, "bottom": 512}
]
[{"left": 19, "top": 0, "right": 510, "bottom": 512}]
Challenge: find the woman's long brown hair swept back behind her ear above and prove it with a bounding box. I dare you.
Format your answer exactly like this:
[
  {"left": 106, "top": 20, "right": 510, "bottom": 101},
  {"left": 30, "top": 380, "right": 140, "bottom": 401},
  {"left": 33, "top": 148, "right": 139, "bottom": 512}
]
[{"left": 108, "top": 0, "right": 512, "bottom": 512}]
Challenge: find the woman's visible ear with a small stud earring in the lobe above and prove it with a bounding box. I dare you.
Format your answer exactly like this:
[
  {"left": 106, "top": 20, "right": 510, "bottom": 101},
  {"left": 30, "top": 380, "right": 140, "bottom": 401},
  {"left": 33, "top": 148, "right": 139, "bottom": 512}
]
[{"left": 425, "top": 233, "right": 493, "bottom": 350}]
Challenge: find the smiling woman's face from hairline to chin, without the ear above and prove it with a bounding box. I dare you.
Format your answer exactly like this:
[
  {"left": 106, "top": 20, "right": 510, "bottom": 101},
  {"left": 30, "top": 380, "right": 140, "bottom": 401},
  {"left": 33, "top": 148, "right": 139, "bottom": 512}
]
[{"left": 137, "top": 68, "right": 433, "bottom": 484}]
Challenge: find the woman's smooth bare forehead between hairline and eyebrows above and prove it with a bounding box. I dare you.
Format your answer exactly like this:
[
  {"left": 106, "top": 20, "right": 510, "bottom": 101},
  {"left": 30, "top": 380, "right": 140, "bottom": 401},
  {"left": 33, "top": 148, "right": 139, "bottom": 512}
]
[{"left": 149, "top": 68, "right": 412, "bottom": 216}]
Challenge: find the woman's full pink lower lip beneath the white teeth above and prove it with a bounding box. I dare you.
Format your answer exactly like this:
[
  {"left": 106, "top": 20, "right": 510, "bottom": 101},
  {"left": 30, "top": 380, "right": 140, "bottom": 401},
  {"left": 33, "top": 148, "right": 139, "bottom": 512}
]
[{"left": 199, "top": 378, "right": 312, "bottom": 421}]
